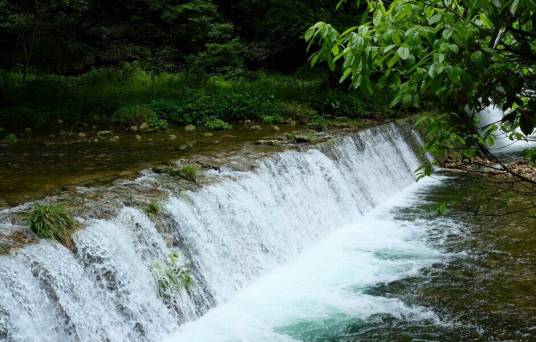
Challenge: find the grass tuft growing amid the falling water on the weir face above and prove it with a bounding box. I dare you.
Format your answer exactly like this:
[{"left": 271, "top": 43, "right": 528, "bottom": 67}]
[{"left": 150, "top": 252, "right": 193, "bottom": 301}]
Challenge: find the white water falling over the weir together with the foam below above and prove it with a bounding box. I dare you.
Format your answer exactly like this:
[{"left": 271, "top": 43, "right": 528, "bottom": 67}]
[{"left": 0, "top": 124, "right": 448, "bottom": 341}]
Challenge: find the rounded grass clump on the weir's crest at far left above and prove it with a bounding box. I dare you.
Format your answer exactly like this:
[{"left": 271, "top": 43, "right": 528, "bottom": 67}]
[{"left": 26, "top": 204, "right": 76, "bottom": 246}]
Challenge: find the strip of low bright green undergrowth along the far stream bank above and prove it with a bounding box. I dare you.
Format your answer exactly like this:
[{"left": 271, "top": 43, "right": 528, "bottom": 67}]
[{"left": 0, "top": 65, "right": 386, "bottom": 131}]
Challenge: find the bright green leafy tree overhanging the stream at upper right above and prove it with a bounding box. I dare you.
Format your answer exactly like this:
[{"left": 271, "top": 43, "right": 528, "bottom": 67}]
[{"left": 305, "top": 0, "right": 536, "bottom": 185}]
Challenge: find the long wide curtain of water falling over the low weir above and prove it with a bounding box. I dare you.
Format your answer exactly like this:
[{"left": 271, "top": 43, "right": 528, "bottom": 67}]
[{"left": 0, "top": 123, "right": 428, "bottom": 341}]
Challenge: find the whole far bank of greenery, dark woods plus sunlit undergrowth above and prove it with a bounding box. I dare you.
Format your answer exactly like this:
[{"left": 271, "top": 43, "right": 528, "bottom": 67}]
[{"left": 0, "top": 0, "right": 394, "bottom": 131}]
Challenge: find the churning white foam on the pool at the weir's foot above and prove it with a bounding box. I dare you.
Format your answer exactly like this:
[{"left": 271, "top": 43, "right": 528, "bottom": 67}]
[{"left": 165, "top": 180, "right": 445, "bottom": 342}]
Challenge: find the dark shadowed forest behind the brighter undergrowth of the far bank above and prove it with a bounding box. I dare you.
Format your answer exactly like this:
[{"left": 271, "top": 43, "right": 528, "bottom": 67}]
[{"left": 0, "top": 0, "right": 351, "bottom": 74}]
